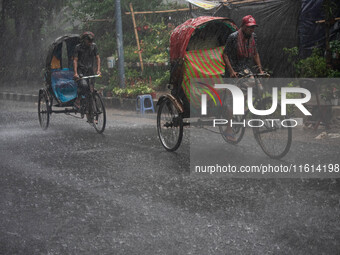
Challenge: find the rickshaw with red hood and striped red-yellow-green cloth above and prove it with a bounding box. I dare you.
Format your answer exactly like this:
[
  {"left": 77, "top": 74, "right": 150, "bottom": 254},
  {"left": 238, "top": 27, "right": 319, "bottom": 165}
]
[{"left": 157, "top": 16, "right": 292, "bottom": 158}]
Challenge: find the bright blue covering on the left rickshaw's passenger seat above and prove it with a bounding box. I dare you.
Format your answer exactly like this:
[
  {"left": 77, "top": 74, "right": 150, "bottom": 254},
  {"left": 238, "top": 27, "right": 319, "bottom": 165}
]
[{"left": 51, "top": 68, "right": 77, "bottom": 103}]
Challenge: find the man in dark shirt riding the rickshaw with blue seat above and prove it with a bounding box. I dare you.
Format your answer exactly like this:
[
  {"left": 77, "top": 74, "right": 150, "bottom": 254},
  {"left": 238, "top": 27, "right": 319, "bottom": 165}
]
[{"left": 73, "top": 32, "right": 101, "bottom": 109}]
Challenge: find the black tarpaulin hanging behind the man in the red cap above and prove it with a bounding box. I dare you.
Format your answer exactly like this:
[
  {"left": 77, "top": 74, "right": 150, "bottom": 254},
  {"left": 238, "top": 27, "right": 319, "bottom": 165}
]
[{"left": 216, "top": 0, "right": 301, "bottom": 77}]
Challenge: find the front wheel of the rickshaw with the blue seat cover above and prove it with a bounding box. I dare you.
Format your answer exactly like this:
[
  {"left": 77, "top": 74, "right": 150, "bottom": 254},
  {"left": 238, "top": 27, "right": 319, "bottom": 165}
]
[{"left": 92, "top": 93, "right": 106, "bottom": 134}]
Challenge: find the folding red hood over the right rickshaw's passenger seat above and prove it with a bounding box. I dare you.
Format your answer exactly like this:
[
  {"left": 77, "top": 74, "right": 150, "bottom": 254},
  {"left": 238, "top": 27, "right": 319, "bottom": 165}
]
[{"left": 170, "top": 16, "right": 237, "bottom": 60}]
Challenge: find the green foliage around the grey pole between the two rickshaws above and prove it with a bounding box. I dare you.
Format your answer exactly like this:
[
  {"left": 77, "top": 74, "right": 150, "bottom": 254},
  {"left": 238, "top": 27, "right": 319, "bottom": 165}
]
[{"left": 71, "top": 0, "right": 180, "bottom": 96}]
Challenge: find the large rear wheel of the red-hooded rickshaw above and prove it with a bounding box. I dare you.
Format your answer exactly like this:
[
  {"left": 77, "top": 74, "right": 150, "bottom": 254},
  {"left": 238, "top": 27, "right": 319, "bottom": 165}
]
[{"left": 157, "top": 99, "right": 183, "bottom": 151}]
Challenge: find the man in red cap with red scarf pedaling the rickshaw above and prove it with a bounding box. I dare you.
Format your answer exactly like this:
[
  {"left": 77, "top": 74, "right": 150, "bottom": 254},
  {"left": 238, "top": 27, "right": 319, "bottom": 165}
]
[{"left": 223, "top": 15, "right": 264, "bottom": 142}]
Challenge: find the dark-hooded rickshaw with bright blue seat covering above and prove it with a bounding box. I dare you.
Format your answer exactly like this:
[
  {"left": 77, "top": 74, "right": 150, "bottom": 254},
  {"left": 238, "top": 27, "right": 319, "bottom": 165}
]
[{"left": 38, "top": 34, "right": 106, "bottom": 133}]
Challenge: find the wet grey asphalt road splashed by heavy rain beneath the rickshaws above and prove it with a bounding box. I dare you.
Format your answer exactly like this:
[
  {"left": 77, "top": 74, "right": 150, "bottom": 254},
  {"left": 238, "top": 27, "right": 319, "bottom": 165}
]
[{"left": 0, "top": 101, "right": 340, "bottom": 254}]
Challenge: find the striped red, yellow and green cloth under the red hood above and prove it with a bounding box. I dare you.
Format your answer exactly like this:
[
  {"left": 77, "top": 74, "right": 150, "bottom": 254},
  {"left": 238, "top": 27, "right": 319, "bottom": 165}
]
[{"left": 182, "top": 46, "right": 225, "bottom": 106}]
